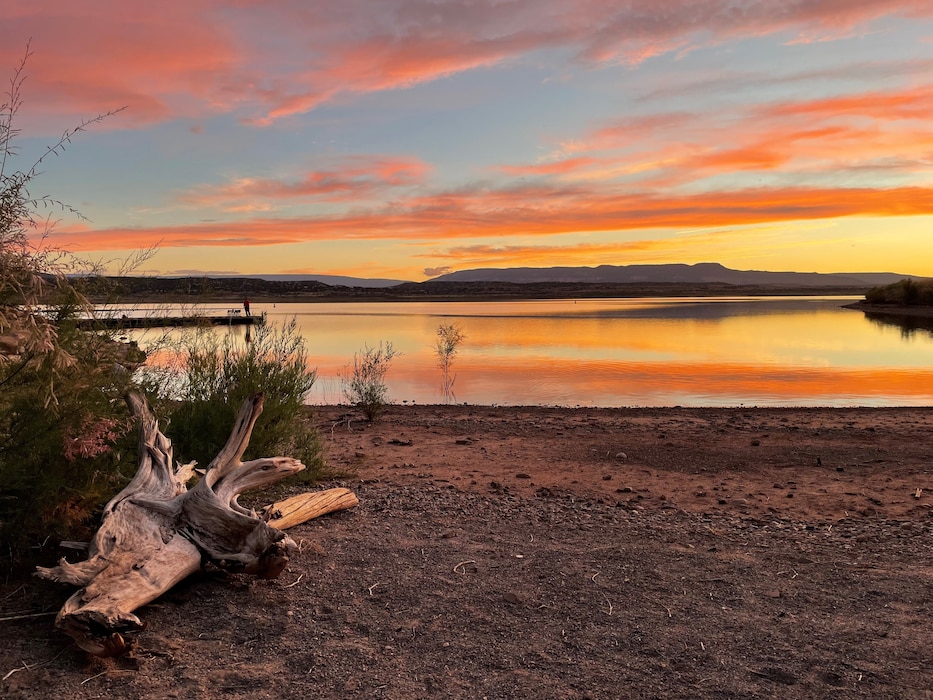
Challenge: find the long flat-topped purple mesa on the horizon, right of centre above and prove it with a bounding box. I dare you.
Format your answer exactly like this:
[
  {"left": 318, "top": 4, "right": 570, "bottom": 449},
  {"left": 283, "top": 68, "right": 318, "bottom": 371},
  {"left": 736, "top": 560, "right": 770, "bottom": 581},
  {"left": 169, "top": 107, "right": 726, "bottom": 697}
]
[{"left": 430, "top": 263, "right": 920, "bottom": 288}]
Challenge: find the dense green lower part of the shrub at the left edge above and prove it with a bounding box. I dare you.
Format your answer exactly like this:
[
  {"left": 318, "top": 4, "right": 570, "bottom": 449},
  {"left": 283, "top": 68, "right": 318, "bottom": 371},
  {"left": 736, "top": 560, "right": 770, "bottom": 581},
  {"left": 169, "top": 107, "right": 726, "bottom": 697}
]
[{"left": 0, "top": 308, "right": 141, "bottom": 563}]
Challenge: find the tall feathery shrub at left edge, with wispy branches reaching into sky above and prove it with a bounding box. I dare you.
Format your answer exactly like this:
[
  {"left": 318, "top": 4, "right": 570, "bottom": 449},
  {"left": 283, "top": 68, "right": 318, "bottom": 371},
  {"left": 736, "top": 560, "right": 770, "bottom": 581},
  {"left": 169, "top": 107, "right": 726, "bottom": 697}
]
[{"left": 0, "top": 46, "right": 140, "bottom": 564}]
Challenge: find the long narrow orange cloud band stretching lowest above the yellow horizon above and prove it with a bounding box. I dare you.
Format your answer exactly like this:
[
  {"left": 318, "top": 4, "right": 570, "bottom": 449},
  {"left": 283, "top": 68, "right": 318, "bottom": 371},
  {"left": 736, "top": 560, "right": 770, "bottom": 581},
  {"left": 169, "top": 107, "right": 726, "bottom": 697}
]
[{"left": 49, "top": 187, "right": 933, "bottom": 251}]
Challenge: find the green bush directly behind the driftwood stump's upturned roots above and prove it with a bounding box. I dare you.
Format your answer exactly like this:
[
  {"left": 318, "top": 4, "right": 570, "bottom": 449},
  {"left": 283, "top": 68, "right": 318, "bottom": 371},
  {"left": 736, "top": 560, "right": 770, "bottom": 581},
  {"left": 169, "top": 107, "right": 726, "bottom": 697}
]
[{"left": 140, "top": 319, "right": 326, "bottom": 480}]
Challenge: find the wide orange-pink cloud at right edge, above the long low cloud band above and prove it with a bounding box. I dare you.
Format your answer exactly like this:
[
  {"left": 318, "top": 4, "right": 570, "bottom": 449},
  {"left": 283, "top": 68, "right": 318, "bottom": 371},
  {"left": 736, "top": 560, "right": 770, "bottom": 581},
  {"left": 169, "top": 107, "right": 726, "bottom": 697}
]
[{"left": 516, "top": 81, "right": 933, "bottom": 189}]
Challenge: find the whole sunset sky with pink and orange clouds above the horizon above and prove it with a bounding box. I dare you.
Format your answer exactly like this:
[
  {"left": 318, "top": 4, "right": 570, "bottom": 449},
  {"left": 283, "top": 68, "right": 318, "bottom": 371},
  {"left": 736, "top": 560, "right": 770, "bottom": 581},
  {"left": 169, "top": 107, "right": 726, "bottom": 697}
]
[{"left": 0, "top": 0, "right": 933, "bottom": 281}]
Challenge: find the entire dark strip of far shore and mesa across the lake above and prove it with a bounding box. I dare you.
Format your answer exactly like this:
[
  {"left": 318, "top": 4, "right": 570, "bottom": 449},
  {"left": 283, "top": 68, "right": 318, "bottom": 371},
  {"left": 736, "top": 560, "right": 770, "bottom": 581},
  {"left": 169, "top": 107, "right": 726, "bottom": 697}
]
[{"left": 87, "top": 263, "right": 924, "bottom": 303}]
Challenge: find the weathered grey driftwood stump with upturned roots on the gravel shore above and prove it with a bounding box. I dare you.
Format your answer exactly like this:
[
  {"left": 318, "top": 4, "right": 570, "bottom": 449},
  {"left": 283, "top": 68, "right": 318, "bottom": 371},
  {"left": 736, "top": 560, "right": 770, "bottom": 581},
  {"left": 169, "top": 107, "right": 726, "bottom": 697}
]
[{"left": 37, "top": 394, "right": 357, "bottom": 656}]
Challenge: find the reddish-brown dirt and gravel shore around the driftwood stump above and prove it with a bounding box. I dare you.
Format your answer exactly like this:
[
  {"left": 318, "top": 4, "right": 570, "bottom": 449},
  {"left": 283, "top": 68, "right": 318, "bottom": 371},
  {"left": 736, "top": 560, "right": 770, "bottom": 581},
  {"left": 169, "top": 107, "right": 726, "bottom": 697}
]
[{"left": 0, "top": 406, "right": 933, "bottom": 699}]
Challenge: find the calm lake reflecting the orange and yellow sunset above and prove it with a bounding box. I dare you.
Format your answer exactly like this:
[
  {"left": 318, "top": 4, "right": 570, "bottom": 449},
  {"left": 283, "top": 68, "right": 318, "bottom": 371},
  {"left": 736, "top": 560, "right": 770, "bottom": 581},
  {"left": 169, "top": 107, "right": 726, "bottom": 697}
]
[{"left": 117, "top": 297, "right": 933, "bottom": 407}]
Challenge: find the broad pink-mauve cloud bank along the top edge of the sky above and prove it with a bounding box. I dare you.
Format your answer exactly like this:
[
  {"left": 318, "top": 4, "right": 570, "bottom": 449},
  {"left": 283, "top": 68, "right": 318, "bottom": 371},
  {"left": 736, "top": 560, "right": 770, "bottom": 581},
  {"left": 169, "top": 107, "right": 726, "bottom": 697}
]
[{"left": 0, "top": 0, "right": 933, "bottom": 124}]
